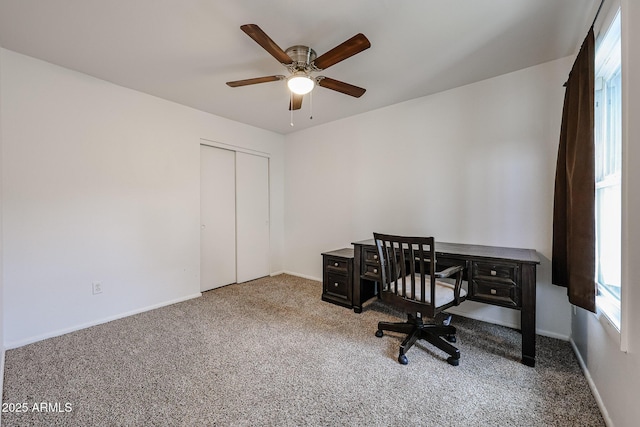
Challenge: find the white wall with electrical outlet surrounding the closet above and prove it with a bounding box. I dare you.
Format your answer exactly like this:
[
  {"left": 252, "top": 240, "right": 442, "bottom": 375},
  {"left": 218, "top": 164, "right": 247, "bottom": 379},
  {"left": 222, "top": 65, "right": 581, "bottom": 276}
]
[{"left": 1, "top": 49, "right": 284, "bottom": 347}]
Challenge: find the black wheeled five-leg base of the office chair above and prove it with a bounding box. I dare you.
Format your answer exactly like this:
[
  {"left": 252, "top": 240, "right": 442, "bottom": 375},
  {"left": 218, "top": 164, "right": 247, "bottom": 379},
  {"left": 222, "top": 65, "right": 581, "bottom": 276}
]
[{"left": 376, "top": 315, "right": 460, "bottom": 366}]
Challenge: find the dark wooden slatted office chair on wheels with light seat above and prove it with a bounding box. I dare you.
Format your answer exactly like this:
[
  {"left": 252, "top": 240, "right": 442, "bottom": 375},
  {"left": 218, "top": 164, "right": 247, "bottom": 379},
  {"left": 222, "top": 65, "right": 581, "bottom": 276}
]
[{"left": 373, "top": 233, "right": 467, "bottom": 366}]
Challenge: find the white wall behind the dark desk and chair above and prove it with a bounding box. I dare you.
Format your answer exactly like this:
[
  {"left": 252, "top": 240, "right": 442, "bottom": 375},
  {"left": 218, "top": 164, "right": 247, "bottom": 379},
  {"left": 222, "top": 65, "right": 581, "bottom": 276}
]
[{"left": 285, "top": 58, "right": 572, "bottom": 339}]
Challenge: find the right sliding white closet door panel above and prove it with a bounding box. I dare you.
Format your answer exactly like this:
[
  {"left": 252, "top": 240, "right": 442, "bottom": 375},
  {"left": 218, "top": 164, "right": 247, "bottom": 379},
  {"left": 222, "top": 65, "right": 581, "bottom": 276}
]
[{"left": 236, "top": 152, "right": 270, "bottom": 283}]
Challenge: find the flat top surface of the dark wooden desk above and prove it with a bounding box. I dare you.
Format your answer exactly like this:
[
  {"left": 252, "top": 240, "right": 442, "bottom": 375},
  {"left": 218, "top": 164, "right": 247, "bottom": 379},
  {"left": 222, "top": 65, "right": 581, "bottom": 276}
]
[{"left": 352, "top": 239, "right": 540, "bottom": 264}]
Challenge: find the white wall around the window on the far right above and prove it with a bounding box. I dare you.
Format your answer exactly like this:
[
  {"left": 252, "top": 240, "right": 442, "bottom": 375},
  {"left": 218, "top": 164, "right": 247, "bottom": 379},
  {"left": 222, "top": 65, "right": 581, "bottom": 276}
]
[{"left": 572, "top": 0, "right": 640, "bottom": 427}]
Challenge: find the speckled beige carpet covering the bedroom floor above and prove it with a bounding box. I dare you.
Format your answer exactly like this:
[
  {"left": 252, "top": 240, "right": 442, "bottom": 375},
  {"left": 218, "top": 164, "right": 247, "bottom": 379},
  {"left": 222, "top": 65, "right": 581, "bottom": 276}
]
[{"left": 2, "top": 275, "right": 604, "bottom": 427}]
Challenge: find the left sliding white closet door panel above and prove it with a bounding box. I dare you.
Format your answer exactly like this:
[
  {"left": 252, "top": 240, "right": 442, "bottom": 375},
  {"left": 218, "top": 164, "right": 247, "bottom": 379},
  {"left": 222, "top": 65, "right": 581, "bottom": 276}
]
[{"left": 200, "top": 145, "right": 236, "bottom": 291}]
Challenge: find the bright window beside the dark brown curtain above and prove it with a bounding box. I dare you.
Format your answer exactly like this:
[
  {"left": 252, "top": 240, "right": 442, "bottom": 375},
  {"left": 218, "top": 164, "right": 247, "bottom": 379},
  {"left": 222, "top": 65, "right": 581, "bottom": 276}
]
[{"left": 594, "top": 11, "right": 622, "bottom": 330}]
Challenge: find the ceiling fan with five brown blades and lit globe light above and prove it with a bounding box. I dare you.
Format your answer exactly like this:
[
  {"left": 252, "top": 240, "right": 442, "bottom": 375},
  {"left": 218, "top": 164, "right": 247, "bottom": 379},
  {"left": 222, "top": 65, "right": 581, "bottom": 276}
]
[{"left": 227, "top": 24, "right": 371, "bottom": 110}]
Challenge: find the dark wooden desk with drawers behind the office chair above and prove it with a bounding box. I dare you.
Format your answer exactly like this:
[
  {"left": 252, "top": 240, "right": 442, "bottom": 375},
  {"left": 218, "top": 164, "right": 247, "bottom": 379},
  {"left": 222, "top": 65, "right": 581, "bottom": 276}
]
[{"left": 352, "top": 239, "right": 540, "bottom": 366}]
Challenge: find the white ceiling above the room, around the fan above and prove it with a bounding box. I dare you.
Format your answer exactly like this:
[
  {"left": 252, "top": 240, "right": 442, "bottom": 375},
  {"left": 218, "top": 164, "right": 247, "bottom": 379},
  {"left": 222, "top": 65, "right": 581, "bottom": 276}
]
[{"left": 0, "top": 0, "right": 599, "bottom": 134}]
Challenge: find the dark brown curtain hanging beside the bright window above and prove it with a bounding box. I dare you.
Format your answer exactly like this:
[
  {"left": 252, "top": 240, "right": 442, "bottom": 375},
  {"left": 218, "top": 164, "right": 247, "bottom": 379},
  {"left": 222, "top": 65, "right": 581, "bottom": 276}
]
[{"left": 551, "top": 27, "right": 596, "bottom": 312}]
